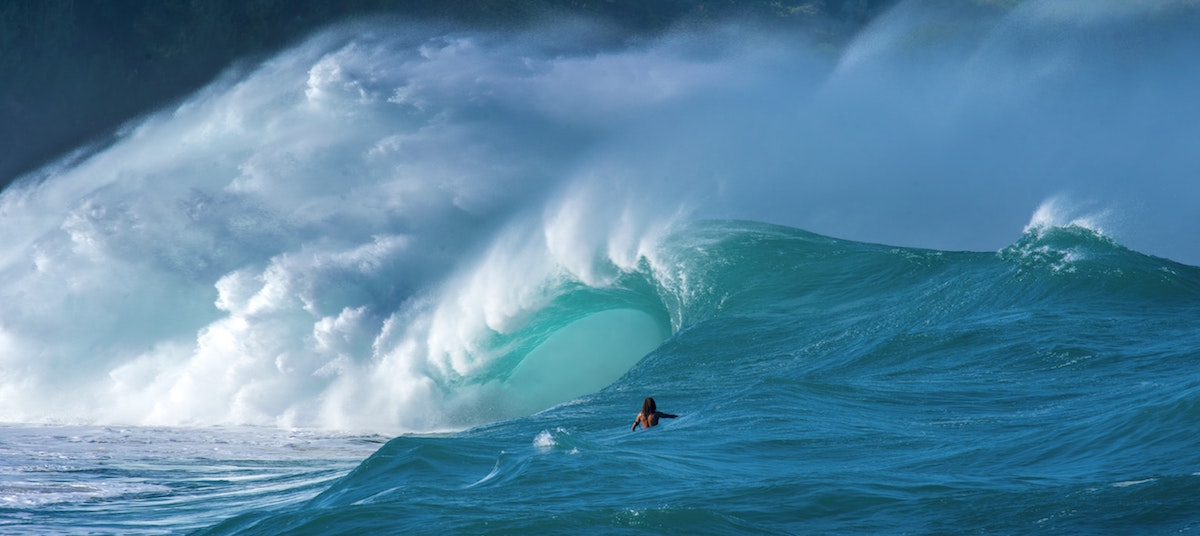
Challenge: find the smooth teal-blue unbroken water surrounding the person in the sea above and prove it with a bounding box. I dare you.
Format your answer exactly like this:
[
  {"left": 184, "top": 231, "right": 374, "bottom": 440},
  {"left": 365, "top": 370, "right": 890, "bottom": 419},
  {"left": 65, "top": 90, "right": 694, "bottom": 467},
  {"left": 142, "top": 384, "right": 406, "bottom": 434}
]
[{"left": 192, "top": 223, "right": 1200, "bottom": 534}]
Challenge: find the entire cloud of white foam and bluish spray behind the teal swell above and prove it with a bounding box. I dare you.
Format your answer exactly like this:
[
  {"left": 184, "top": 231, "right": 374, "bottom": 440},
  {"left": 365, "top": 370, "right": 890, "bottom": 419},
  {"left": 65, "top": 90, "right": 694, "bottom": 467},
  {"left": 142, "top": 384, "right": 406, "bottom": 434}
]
[{"left": 0, "top": 1, "right": 1200, "bottom": 432}]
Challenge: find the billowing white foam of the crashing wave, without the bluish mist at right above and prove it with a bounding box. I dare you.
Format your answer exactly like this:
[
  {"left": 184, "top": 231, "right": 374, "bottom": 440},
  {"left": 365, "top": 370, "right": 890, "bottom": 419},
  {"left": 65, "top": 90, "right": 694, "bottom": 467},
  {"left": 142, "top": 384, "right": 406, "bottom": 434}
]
[{"left": 0, "top": 20, "right": 727, "bottom": 430}]
